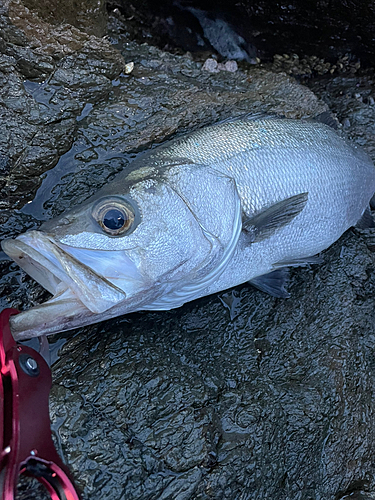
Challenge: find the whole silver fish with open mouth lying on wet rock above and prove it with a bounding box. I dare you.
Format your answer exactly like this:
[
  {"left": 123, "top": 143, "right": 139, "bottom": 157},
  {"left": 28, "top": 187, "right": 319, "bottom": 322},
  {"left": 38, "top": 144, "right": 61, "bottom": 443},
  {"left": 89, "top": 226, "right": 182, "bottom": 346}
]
[{"left": 2, "top": 115, "right": 375, "bottom": 340}]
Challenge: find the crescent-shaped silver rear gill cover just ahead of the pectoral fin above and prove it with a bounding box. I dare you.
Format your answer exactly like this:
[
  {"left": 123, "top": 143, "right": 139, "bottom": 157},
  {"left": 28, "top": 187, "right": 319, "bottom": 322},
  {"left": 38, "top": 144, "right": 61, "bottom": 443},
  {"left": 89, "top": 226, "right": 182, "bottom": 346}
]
[{"left": 144, "top": 164, "right": 242, "bottom": 310}]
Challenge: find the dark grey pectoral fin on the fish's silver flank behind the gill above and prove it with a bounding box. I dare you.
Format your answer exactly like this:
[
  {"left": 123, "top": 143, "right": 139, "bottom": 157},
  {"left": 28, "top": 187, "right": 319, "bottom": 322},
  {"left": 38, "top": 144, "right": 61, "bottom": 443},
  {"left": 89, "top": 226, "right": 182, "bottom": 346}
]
[{"left": 242, "top": 193, "right": 308, "bottom": 243}]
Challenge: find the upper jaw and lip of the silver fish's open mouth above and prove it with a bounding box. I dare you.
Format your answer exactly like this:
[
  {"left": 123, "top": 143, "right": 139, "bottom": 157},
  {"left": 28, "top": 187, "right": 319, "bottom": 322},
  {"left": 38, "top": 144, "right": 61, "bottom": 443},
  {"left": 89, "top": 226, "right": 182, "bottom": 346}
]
[{"left": 2, "top": 231, "right": 126, "bottom": 314}]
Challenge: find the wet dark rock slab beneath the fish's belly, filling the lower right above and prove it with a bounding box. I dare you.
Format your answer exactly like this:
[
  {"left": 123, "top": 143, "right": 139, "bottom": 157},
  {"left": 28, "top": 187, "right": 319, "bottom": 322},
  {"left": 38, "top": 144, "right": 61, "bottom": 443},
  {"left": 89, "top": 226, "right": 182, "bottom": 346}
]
[{"left": 44, "top": 232, "right": 375, "bottom": 500}]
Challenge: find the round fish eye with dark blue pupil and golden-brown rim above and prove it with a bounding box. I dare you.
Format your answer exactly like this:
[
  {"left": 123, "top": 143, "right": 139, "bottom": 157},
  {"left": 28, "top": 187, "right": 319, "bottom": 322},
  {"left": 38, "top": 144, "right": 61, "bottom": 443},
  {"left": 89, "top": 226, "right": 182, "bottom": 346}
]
[{"left": 93, "top": 200, "right": 135, "bottom": 236}]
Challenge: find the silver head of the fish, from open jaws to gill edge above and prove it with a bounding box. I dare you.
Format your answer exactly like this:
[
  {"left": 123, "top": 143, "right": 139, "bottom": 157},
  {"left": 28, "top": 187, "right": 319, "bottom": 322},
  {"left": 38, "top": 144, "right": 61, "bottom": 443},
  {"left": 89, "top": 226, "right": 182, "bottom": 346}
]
[{"left": 2, "top": 165, "right": 241, "bottom": 339}]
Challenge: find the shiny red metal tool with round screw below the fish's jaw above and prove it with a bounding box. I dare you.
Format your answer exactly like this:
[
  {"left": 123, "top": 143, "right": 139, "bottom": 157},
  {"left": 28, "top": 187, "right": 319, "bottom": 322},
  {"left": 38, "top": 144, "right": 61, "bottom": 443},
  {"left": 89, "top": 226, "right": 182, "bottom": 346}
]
[{"left": 0, "top": 309, "right": 79, "bottom": 500}]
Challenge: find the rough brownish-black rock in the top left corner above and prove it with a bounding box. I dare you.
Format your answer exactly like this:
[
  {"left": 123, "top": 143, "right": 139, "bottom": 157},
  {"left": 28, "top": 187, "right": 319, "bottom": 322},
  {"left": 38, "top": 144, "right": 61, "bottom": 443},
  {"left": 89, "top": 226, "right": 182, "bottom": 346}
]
[{"left": 0, "top": 0, "right": 125, "bottom": 208}]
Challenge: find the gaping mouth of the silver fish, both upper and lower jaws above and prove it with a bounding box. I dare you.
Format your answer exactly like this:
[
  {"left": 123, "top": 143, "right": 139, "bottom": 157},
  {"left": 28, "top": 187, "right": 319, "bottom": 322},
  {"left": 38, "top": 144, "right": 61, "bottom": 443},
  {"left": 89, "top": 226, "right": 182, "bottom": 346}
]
[{"left": 1, "top": 231, "right": 127, "bottom": 340}]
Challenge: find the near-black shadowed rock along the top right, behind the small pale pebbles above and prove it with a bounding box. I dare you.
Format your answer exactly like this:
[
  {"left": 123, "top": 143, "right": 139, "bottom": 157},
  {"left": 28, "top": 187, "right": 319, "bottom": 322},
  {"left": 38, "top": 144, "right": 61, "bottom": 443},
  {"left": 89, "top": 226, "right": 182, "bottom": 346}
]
[{"left": 109, "top": 0, "right": 375, "bottom": 67}]
